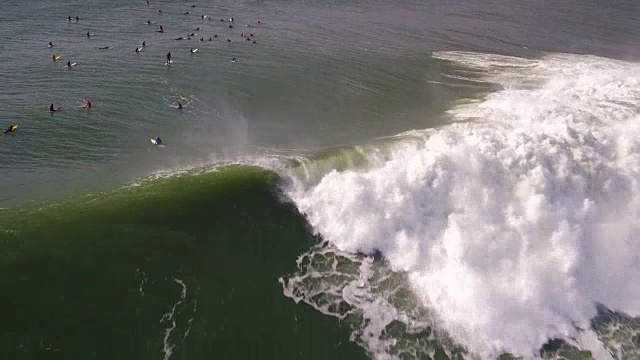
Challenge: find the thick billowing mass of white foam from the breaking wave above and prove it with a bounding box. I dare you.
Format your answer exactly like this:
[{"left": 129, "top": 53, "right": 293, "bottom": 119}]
[{"left": 288, "top": 52, "right": 640, "bottom": 358}]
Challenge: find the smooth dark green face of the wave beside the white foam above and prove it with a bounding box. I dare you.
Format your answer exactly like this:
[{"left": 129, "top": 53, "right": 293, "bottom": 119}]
[{"left": 0, "top": 166, "right": 363, "bottom": 359}]
